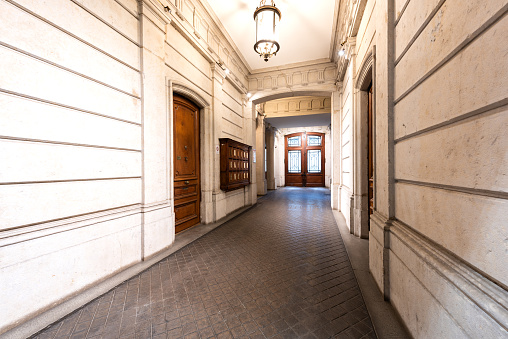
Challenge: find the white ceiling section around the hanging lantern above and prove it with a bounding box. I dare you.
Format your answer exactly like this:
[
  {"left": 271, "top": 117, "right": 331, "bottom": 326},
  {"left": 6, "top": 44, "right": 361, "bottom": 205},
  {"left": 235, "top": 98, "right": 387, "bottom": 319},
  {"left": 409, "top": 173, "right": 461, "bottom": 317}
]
[{"left": 206, "top": 0, "right": 335, "bottom": 70}]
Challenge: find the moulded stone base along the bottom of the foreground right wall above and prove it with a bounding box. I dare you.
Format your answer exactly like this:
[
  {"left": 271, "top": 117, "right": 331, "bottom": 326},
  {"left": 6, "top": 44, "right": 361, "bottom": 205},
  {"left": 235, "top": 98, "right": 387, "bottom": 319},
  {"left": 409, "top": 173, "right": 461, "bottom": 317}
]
[{"left": 389, "top": 221, "right": 508, "bottom": 338}]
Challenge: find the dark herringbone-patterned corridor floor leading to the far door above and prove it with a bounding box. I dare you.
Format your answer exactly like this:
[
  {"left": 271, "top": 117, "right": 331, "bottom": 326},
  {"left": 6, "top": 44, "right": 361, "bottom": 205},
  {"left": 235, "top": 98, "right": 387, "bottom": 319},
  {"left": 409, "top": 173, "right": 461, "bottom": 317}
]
[{"left": 33, "top": 187, "right": 376, "bottom": 339}]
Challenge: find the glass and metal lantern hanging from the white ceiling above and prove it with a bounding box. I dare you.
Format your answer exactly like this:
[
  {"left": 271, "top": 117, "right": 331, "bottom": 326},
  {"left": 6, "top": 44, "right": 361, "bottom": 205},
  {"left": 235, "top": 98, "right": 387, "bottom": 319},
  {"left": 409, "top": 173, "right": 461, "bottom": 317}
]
[{"left": 254, "top": 0, "right": 281, "bottom": 61}]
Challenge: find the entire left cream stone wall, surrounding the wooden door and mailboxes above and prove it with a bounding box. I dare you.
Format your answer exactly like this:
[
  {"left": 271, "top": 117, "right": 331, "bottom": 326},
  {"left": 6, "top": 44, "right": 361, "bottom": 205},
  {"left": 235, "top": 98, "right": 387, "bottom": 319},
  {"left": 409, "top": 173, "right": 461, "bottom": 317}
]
[{"left": 0, "top": 0, "right": 256, "bottom": 333}]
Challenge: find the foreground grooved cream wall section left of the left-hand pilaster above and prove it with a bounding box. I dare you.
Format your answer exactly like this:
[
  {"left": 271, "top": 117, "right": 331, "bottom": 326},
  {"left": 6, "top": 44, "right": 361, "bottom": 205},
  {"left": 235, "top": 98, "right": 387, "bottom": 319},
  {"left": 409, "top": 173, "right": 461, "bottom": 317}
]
[{"left": 0, "top": 0, "right": 142, "bottom": 332}]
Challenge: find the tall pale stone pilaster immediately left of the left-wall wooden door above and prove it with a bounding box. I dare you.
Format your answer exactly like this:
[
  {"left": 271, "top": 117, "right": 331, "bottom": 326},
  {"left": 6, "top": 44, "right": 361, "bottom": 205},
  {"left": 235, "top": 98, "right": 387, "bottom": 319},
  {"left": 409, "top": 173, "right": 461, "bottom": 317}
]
[{"left": 138, "top": 0, "right": 174, "bottom": 260}]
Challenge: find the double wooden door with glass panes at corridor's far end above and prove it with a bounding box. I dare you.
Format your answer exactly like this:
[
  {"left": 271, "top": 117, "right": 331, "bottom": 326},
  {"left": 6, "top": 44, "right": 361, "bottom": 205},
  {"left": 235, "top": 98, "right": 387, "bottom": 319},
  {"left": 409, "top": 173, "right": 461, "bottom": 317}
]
[{"left": 285, "top": 132, "right": 325, "bottom": 187}]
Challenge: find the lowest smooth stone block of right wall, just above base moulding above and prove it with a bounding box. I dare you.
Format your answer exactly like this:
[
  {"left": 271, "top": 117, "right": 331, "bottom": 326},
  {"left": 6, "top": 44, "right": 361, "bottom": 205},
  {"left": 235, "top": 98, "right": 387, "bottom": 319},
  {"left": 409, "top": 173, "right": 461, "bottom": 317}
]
[{"left": 395, "top": 183, "right": 508, "bottom": 286}]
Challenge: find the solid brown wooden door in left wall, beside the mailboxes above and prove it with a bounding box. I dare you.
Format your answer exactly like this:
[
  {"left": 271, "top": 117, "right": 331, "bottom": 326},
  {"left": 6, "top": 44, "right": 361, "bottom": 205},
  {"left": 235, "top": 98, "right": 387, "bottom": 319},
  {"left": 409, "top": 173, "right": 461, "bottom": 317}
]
[{"left": 173, "top": 95, "right": 201, "bottom": 233}]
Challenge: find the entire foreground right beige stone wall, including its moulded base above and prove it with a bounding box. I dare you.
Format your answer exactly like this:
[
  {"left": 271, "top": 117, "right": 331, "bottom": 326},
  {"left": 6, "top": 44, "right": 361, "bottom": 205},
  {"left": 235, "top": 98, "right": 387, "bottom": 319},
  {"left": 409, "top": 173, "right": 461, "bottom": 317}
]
[{"left": 362, "top": 0, "right": 508, "bottom": 338}]
